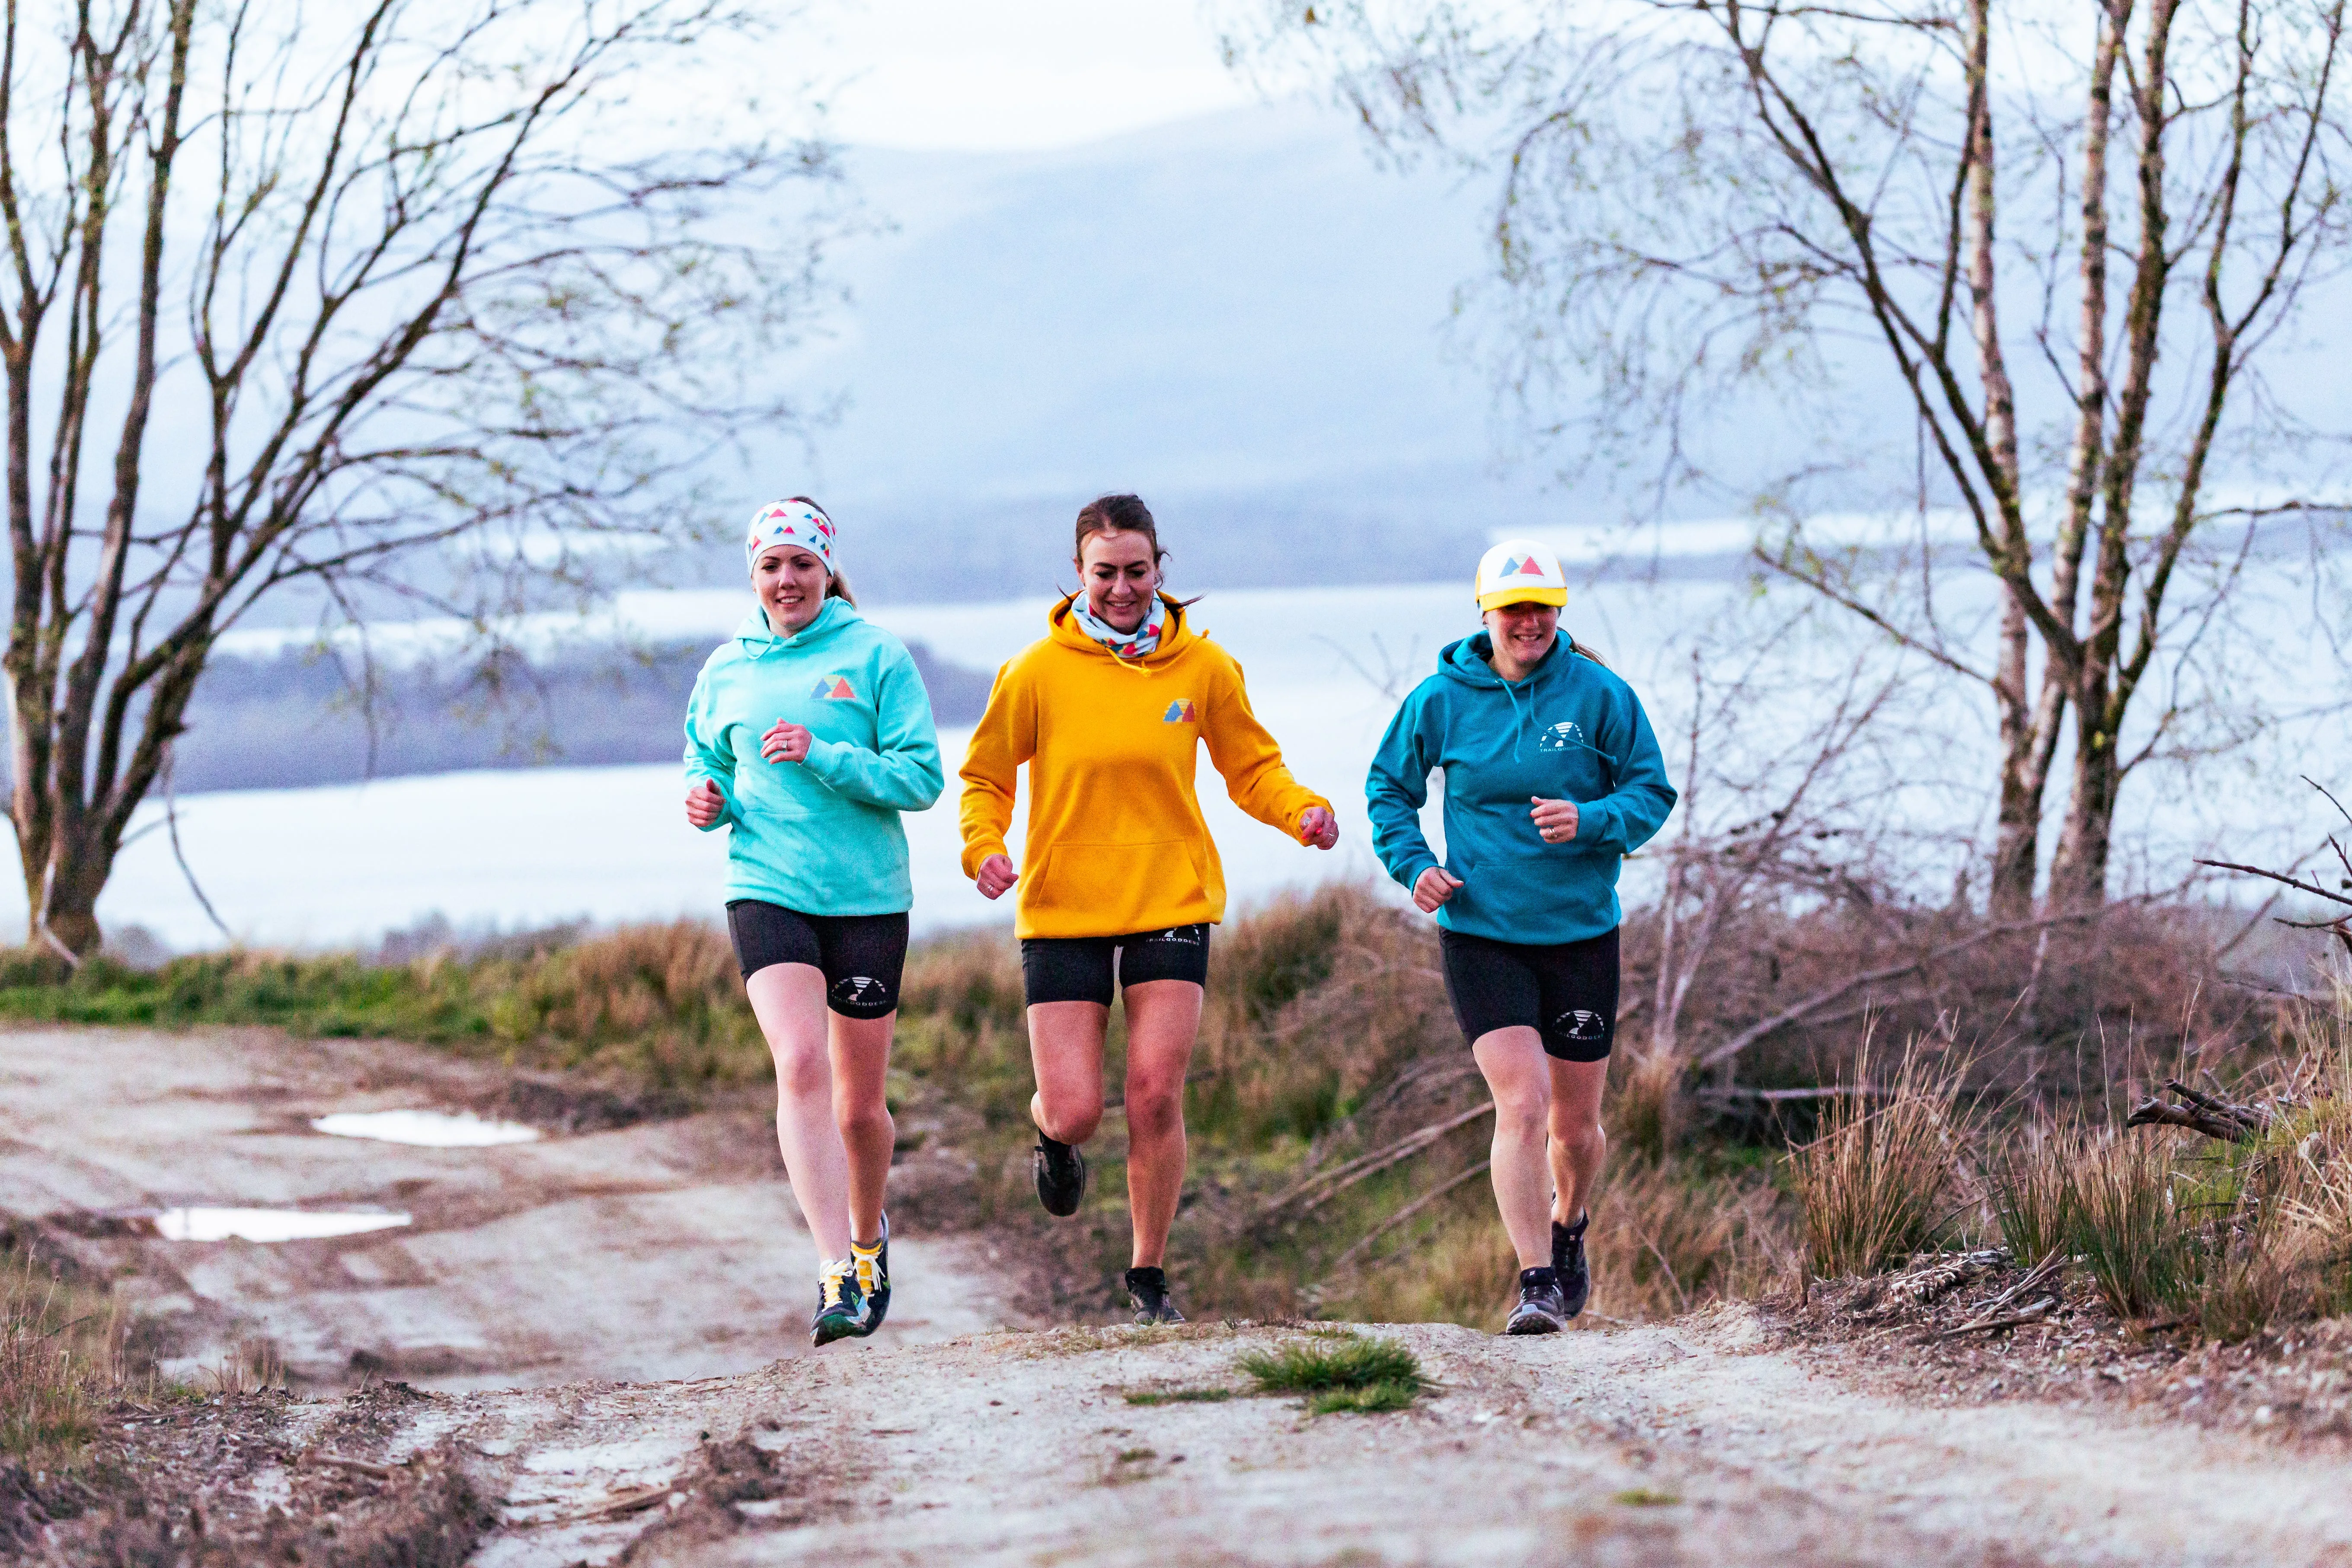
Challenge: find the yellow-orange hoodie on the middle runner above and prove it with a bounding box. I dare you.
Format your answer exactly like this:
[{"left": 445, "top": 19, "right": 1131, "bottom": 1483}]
[{"left": 962, "top": 595, "right": 1331, "bottom": 936}]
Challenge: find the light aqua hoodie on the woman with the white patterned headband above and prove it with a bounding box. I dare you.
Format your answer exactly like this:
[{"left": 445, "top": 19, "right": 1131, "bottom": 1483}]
[{"left": 687, "top": 600, "right": 946, "bottom": 914}]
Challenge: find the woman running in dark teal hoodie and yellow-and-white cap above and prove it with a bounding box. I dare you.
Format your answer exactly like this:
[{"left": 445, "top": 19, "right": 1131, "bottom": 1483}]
[{"left": 1364, "top": 538, "right": 1675, "bottom": 1333}]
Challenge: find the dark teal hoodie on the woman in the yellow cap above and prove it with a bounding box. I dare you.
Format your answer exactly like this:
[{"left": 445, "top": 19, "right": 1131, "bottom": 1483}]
[{"left": 1364, "top": 632, "right": 1675, "bottom": 947}]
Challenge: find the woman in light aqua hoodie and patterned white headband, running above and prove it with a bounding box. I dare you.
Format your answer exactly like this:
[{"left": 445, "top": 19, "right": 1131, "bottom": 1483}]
[{"left": 687, "top": 496, "right": 946, "bottom": 1344}]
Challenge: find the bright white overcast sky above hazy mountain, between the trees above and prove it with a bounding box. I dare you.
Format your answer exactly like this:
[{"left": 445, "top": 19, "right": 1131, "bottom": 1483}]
[{"left": 799, "top": 0, "right": 1254, "bottom": 150}]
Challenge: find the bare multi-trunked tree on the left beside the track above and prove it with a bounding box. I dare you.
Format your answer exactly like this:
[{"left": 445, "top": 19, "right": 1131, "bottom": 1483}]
[{"left": 0, "top": 0, "right": 833, "bottom": 957}]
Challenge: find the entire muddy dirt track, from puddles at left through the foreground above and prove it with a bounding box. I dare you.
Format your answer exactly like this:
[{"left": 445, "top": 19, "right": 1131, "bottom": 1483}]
[{"left": 0, "top": 1032, "right": 2352, "bottom": 1568}]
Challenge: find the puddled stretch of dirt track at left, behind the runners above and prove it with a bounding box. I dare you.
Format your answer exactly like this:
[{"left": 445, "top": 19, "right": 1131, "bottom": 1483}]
[{"left": 0, "top": 1030, "right": 1025, "bottom": 1392}]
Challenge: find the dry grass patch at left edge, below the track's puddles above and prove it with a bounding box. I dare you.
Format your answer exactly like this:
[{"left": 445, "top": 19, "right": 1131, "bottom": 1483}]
[{"left": 0, "top": 1258, "right": 122, "bottom": 1469}]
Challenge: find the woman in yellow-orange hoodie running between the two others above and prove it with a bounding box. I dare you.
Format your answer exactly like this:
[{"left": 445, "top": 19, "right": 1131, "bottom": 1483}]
[{"left": 962, "top": 496, "right": 1338, "bottom": 1323}]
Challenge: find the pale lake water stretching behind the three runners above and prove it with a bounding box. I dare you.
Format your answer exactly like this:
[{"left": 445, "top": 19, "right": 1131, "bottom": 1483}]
[{"left": 13, "top": 578, "right": 2345, "bottom": 950}]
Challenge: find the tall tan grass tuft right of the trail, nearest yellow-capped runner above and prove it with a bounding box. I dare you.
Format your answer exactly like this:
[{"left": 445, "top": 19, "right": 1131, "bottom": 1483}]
[{"left": 1790, "top": 1041, "right": 1969, "bottom": 1279}]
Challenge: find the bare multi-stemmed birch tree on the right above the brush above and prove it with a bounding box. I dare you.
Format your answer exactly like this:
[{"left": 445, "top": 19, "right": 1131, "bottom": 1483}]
[{"left": 1228, "top": 0, "right": 2347, "bottom": 919}]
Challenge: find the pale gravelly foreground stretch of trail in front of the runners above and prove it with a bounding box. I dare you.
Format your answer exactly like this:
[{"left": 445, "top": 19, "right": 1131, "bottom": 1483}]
[{"left": 402, "top": 1314, "right": 2352, "bottom": 1568}]
